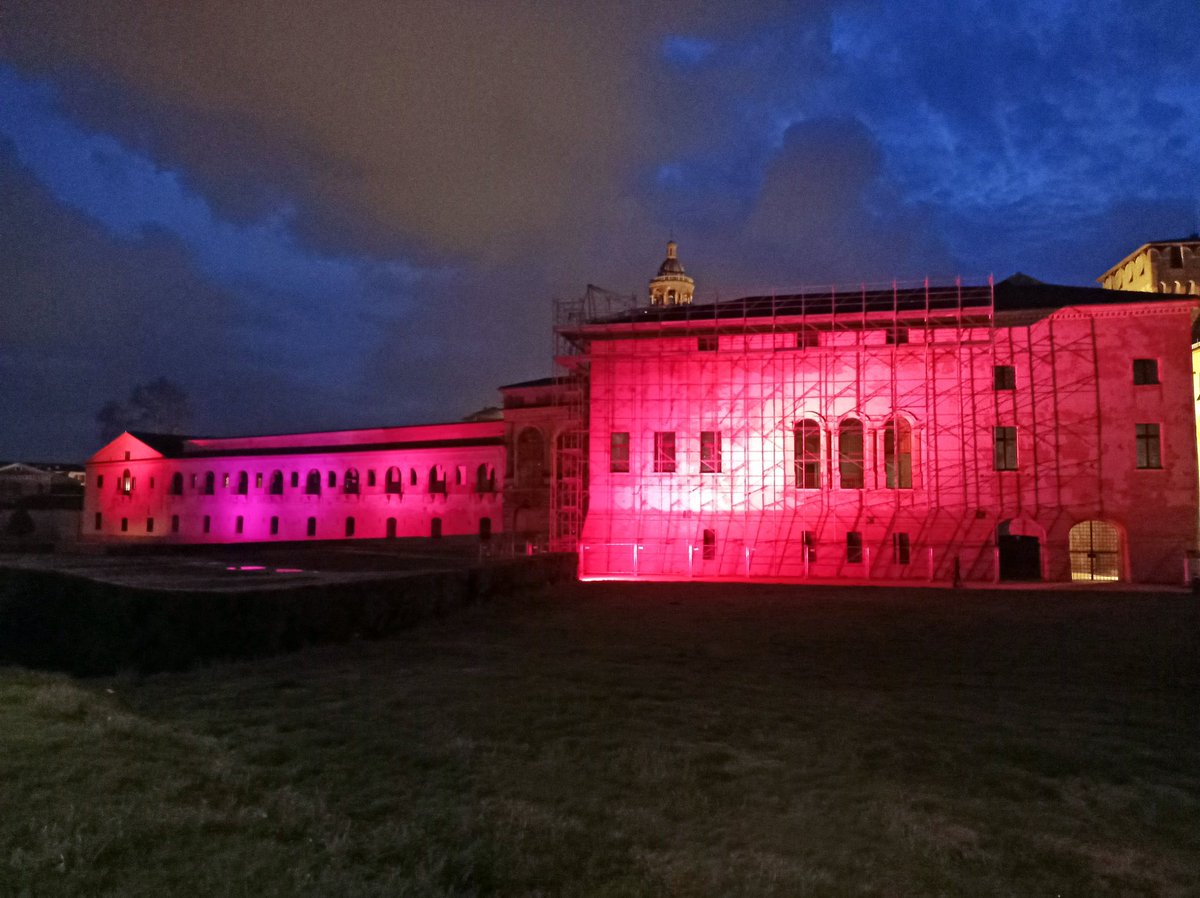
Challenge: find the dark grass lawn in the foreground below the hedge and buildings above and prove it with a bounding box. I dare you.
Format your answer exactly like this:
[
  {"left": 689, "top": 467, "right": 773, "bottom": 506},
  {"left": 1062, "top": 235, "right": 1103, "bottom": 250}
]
[{"left": 0, "top": 583, "right": 1200, "bottom": 896}]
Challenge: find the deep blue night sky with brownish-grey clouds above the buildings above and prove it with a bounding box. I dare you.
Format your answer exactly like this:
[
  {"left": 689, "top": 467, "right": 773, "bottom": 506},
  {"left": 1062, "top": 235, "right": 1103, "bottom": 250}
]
[{"left": 0, "top": 0, "right": 1200, "bottom": 461}]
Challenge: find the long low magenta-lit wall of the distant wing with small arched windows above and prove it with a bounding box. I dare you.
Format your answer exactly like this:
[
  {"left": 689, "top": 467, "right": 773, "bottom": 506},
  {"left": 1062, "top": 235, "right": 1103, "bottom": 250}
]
[{"left": 83, "top": 421, "right": 504, "bottom": 543}]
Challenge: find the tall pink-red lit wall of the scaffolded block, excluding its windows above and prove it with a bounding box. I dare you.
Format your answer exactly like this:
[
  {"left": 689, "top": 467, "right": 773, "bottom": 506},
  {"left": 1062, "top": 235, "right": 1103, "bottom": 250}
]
[{"left": 581, "top": 301, "right": 1198, "bottom": 582}]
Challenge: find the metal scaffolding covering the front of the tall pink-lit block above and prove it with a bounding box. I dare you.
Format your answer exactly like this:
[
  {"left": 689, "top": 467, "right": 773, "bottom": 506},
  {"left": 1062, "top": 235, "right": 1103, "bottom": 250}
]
[{"left": 552, "top": 279, "right": 1022, "bottom": 579}]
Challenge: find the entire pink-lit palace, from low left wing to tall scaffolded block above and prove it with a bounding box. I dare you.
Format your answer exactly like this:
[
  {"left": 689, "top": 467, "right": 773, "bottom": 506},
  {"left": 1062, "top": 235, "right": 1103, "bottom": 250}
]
[{"left": 84, "top": 240, "right": 1200, "bottom": 582}]
